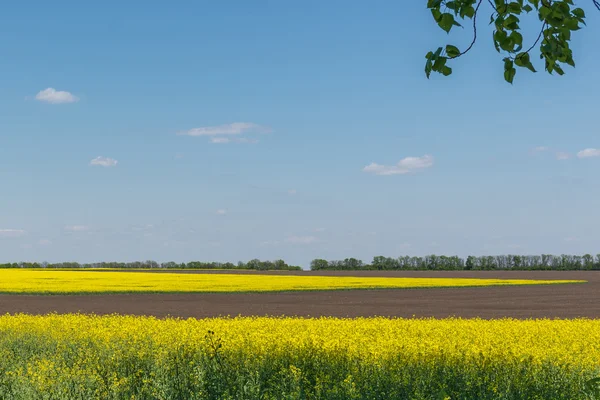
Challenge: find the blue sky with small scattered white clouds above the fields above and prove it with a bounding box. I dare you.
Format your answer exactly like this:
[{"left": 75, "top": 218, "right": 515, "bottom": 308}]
[{"left": 0, "top": 0, "right": 600, "bottom": 266}]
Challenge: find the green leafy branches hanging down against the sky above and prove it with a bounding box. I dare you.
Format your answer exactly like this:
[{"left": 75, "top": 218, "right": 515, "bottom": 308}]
[{"left": 425, "top": 0, "right": 600, "bottom": 83}]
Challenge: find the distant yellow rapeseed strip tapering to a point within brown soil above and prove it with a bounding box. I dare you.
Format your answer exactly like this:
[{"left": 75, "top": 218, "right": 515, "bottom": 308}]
[{"left": 0, "top": 269, "right": 585, "bottom": 294}]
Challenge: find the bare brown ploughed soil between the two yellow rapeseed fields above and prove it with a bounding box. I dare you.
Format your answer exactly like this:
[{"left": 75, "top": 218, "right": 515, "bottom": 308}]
[{"left": 0, "top": 271, "right": 600, "bottom": 318}]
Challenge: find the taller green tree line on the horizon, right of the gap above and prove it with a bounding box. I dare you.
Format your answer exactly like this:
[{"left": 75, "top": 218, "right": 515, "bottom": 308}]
[{"left": 310, "top": 254, "right": 600, "bottom": 271}]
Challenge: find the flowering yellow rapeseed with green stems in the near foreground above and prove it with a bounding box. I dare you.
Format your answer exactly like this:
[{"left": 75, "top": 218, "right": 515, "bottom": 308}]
[{"left": 0, "top": 315, "right": 600, "bottom": 400}]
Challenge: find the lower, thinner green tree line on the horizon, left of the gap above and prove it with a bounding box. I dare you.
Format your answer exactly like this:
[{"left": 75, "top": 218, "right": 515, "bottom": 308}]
[{"left": 0, "top": 259, "right": 302, "bottom": 271}]
